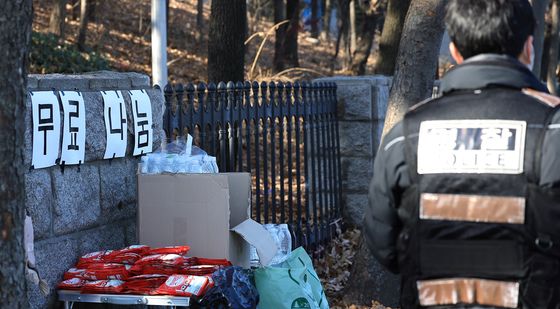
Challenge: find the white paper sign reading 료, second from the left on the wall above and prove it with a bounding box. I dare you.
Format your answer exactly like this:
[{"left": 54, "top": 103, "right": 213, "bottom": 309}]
[{"left": 60, "top": 91, "right": 86, "bottom": 165}]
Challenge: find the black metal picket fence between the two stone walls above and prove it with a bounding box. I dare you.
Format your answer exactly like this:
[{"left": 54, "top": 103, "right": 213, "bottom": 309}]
[{"left": 164, "top": 82, "right": 342, "bottom": 250}]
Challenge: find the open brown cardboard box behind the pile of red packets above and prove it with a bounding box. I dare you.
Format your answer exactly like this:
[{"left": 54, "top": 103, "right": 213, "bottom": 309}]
[{"left": 138, "top": 173, "right": 253, "bottom": 267}]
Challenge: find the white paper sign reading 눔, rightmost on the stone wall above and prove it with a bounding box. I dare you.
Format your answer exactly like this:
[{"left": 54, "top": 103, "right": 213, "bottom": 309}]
[{"left": 130, "top": 90, "right": 153, "bottom": 156}]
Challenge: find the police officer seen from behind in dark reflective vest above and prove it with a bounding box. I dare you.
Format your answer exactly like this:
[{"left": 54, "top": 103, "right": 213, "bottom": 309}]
[{"left": 364, "top": 0, "right": 560, "bottom": 308}]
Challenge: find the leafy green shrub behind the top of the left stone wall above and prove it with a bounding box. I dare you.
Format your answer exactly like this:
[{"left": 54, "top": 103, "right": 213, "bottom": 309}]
[{"left": 29, "top": 31, "right": 110, "bottom": 74}]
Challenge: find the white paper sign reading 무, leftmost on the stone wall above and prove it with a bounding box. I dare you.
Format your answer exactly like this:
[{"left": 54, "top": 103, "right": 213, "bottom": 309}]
[{"left": 31, "top": 91, "right": 60, "bottom": 168}]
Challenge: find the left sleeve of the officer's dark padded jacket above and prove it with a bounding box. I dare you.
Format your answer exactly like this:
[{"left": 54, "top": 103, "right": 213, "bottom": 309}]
[{"left": 362, "top": 123, "right": 410, "bottom": 273}]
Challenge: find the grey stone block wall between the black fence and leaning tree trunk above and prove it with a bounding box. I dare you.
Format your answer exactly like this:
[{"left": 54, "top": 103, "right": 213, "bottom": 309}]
[{"left": 315, "top": 76, "right": 391, "bottom": 226}]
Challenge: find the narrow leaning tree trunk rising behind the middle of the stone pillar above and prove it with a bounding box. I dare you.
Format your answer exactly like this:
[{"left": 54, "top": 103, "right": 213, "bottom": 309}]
[{"left": 351, "top": 7, "right": 380, "bottom": 75}]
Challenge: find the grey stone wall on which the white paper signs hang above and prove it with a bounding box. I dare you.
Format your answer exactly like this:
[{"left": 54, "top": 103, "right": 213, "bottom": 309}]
[{"left": 24, "top": 71, "right": 164, "bottom": 308}]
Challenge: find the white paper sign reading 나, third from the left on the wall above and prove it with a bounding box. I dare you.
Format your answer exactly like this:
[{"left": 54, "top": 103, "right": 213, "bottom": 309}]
[{"left": 101, "top": 91, "right": 128, "bottom": 159}]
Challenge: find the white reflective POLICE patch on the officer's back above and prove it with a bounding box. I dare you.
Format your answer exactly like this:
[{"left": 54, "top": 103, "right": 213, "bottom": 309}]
[{"left": 418, "top": 120, "right": 527, "bottom": 174}]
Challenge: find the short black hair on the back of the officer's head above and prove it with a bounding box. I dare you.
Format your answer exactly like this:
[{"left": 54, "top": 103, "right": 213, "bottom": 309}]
[{"left": 445, "top": 0, "right": 535, "bottom": 59}]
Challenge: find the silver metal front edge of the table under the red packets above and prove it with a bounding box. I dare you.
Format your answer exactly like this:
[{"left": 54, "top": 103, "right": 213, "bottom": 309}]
[{"left": 58, "top": 290, "right": 190, "bottom": 309}]
